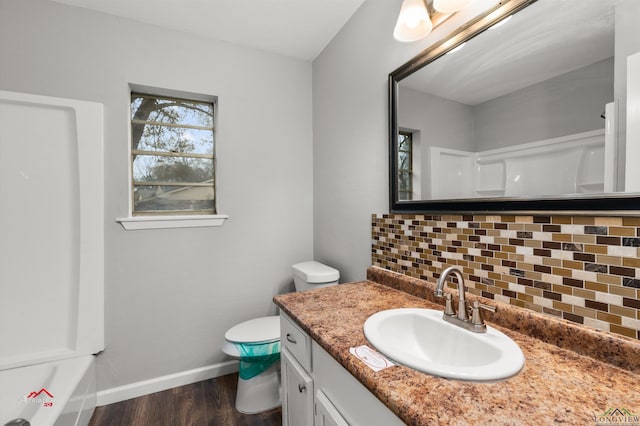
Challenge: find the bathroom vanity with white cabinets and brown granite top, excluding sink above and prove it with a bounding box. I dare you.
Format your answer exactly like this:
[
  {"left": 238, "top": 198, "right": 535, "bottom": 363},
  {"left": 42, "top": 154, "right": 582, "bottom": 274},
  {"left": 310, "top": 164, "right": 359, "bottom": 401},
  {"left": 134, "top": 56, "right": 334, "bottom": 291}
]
[{"left": 274, "top": 267, "right": 640, "bottom": 425}]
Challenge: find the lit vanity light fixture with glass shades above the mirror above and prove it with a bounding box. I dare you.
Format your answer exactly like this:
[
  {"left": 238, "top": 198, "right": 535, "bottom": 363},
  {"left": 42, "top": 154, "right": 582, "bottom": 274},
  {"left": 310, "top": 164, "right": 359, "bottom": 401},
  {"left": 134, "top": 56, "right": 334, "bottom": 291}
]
[{"left": 393, "top": 0, "right": 473, "bottom": 42}]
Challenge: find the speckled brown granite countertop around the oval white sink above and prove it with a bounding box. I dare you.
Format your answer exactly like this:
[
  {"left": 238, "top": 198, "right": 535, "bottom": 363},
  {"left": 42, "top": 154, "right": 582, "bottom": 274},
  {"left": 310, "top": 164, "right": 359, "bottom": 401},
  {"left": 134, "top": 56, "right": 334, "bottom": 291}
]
[{"left": 274, "top": 270, "right": 640, "bottom": 425}]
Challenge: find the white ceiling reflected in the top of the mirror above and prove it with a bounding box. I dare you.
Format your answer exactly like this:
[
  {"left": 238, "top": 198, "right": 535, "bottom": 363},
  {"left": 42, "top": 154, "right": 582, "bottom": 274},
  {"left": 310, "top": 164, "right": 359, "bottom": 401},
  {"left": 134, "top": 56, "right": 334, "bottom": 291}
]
[{"left": 401, "top": 0, "right": 620, "bottom": 105}]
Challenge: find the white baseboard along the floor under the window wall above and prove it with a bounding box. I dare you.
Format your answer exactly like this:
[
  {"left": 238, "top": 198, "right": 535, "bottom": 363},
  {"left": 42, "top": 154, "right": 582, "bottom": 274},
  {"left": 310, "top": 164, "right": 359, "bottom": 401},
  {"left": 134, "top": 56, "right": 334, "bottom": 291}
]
[{"left": 96, "top": 360, "right": 238, "bottom": 407}]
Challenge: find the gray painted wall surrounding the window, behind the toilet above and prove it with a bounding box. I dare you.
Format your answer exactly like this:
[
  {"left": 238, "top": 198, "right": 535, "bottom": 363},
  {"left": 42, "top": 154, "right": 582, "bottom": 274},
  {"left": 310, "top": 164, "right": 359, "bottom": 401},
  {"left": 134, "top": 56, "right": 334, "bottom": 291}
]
[{"left": 0, "top": 0, "right": 312, "bottom": 389}]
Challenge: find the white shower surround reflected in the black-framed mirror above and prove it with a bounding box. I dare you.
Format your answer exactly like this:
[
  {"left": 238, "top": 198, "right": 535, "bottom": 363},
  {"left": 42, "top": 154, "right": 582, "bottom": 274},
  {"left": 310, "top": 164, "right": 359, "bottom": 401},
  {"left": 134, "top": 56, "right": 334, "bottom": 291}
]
[{"left": 429, "top": 129, "right": 615, "bottom": 199}]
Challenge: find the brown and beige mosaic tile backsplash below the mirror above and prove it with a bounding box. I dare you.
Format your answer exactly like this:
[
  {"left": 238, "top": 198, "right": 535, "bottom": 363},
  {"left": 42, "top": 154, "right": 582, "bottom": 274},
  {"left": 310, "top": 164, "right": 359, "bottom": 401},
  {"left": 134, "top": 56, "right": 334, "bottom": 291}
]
[{"left": 371, "top": 214, "right": 640, "bottom": 339}]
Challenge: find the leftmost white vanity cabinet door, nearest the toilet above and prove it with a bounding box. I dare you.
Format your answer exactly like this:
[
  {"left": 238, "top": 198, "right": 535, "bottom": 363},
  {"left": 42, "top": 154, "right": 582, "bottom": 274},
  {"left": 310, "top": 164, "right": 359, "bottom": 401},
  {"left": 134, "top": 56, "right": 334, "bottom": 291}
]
[{"left": 280, "top": 348, "right": 313, "bottom": 426}]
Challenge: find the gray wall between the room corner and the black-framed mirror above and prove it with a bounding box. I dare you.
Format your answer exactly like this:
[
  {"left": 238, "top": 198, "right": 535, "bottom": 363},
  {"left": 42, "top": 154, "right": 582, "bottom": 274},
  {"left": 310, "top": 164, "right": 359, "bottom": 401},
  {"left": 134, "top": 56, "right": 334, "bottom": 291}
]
[{"left": 313, "top": 0, "right": 482, "bottom": 281}]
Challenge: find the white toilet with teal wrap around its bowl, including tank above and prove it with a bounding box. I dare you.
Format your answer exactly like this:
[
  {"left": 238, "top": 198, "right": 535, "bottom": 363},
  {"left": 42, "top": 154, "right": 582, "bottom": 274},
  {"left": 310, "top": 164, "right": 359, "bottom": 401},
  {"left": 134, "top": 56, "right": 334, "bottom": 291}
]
[{"left": 222, "top": 261, "right": 340, "bottom": 414}]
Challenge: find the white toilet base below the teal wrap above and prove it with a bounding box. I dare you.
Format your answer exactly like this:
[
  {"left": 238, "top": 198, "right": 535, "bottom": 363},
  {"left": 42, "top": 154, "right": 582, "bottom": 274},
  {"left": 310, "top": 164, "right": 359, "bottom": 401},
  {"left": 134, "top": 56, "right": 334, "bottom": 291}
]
[{"left": 231, "top": 362, "right": 282, "bottom": 414}]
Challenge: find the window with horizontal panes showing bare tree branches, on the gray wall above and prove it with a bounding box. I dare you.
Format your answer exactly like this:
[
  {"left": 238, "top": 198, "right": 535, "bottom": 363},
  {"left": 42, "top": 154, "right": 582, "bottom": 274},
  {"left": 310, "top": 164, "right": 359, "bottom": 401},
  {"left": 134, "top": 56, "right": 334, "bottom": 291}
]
[{"left": 131, "top": 93, "right": 216, "bottom": 216}]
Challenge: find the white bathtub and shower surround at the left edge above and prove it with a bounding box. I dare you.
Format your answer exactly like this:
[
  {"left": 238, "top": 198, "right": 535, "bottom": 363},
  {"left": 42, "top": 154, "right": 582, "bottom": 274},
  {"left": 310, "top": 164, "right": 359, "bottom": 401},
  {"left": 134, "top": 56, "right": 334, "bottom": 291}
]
[{"left": 0, "top": 91, "right": 104, "bottom": 425}]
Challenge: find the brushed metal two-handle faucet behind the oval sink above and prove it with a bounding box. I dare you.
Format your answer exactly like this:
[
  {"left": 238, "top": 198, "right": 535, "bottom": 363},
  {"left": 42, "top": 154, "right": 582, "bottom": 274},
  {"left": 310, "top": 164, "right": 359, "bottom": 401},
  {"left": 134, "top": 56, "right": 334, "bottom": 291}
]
[{"left": 433, "top": 266, "right": 496, "bottom": 333}]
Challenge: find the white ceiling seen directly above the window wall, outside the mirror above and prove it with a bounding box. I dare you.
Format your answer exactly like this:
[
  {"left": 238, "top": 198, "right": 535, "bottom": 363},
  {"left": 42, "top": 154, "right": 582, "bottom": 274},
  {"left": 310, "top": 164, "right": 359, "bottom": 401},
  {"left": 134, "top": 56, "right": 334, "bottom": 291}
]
[{"left": 47, "top": 0, "right": 364, "bottom": 61}]
